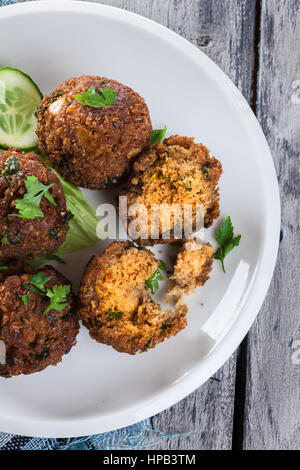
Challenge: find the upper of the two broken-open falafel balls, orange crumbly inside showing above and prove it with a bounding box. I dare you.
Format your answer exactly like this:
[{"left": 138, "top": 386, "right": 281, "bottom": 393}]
[{"left": 120, "top": 135, "right": 222, "bottom": 245}]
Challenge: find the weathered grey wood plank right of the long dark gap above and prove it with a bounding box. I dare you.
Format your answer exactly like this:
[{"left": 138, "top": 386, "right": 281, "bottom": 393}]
[{"left": 244, "top": 0, "right": 300, "bottom": 450}]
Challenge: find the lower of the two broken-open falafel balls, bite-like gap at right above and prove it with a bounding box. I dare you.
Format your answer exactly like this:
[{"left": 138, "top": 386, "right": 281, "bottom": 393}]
[{"left": 79, "top": 242, "right": 186, "bottom": 354}]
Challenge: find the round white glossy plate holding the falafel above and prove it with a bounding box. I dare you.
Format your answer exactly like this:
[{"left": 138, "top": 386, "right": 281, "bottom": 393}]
[{"left": 0, "top": 1, "right": 280, "bottom": 437}]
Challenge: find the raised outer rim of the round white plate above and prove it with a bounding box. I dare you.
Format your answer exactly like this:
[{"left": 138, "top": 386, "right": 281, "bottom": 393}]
[{"left": 0, "top": 0, "right": 281, "bottom": 438}]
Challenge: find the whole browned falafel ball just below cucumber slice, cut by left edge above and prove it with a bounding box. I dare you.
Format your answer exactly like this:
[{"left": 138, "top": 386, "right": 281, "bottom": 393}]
[{"left": 0, "top": 149, "right": 72, "bottom": 259}]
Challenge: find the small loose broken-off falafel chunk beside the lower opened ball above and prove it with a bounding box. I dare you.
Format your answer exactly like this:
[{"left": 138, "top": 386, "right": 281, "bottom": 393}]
[{"left": 164, "top": 238, "right": 214, "bottom": 306}]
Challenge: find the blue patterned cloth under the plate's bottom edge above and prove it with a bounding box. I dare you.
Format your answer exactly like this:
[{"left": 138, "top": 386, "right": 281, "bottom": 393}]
[{"left": 0, "top": 0, "right": 189, "bottom": 450}]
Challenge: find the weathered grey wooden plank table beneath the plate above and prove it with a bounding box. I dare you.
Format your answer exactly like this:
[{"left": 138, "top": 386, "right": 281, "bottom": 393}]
[{"left": 21, "top": 0, "right": 300, "bottom": 450}]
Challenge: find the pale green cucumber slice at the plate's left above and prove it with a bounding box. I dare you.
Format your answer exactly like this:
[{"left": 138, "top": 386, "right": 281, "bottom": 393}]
[{"left": 0, "top": 67, "right": 43, "bottom": 150}]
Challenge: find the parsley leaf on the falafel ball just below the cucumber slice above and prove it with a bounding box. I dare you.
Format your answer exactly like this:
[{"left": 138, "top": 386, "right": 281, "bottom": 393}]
[{"left": 10, "top": 175, "right": 57, "bottom": 219}]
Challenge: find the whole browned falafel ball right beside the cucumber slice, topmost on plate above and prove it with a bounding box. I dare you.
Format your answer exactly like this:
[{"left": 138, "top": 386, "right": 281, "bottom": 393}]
[{"left": 36, "top": 76, "right": 152, "bottom": 189}]
